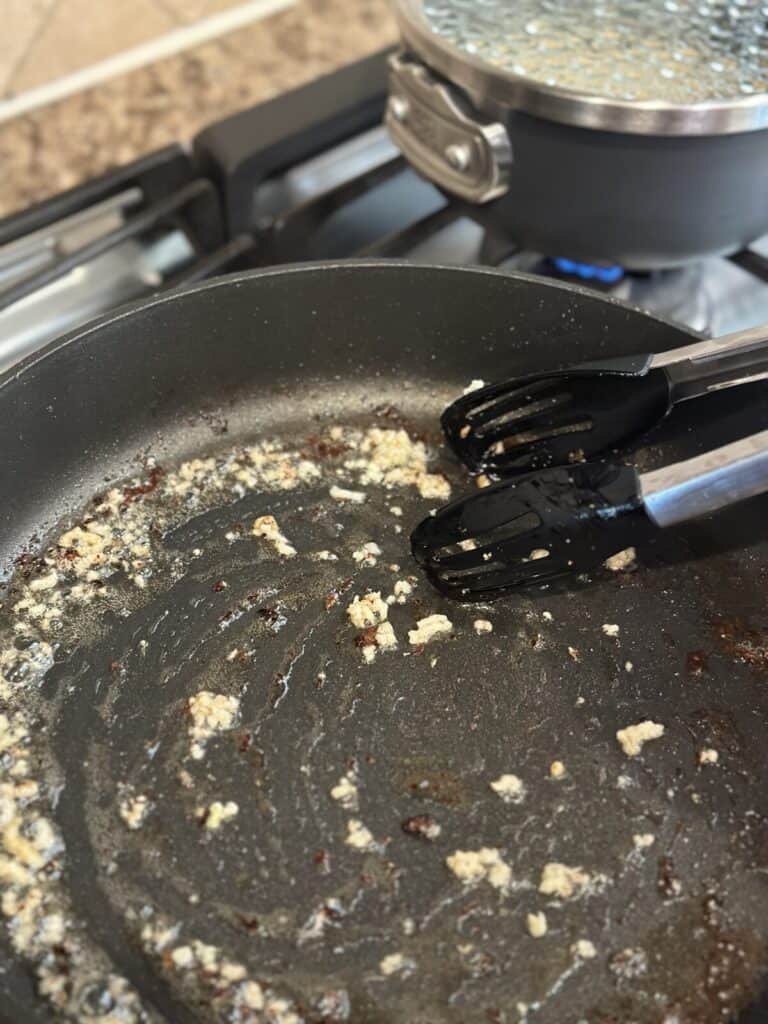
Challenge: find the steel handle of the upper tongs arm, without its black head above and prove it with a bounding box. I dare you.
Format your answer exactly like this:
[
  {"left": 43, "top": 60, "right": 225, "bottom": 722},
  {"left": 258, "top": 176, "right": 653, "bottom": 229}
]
[{"left": 648, "top": 325, "right": 768, "bottom": 402}]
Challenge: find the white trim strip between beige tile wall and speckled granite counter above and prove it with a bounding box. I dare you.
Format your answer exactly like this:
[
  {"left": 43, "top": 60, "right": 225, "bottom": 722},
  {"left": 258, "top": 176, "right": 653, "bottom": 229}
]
[{"left": 0, "top": 0, "right": 297, "bottom": 124}]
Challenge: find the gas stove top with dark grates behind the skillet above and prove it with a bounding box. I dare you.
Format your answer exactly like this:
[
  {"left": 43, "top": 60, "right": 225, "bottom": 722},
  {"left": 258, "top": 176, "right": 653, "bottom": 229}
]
[{"left": 0, "top": 51, "right": 768, "bottom": 370}]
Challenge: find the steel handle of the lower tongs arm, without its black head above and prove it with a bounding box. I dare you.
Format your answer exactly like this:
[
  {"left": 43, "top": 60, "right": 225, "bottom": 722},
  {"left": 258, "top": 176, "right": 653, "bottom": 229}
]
[{"left": 640, "top": 430, "right": 768, "bottom": 532}]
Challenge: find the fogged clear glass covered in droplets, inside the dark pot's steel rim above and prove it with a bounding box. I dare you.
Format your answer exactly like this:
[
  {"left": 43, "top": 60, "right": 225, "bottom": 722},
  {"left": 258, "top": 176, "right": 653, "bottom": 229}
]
[{"left": 424, "top": 0, "right": 768, "bottom": 103}]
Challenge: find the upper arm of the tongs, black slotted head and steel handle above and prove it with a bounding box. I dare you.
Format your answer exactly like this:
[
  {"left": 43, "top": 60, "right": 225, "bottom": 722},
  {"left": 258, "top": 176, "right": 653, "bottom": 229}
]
[{"left": 441, "top": 326, "right": 768, "bottom": 477}]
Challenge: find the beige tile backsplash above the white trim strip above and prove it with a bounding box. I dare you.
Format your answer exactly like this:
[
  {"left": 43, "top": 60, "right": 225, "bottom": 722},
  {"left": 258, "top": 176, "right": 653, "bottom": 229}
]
[{"left": 0, "top": 0, "right": 242, "bottom": 99}]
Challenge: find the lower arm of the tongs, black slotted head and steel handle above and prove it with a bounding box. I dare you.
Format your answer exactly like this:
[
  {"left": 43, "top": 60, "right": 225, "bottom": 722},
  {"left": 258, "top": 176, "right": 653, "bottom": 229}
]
[{"left": 411, "top": 430, "right": 768, "bottom": 601}]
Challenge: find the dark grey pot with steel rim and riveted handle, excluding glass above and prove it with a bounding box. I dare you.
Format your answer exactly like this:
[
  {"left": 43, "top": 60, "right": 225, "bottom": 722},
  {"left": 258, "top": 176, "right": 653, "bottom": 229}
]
[{"left": 386, "top": 0, "right": 768, "bottom": 269}]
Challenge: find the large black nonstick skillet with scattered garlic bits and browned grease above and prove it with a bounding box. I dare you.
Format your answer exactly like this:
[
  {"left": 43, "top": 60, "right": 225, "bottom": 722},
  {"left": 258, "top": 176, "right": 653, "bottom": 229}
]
[{"left": 0, "top": 264, "right": 768, "bottom": 1024}]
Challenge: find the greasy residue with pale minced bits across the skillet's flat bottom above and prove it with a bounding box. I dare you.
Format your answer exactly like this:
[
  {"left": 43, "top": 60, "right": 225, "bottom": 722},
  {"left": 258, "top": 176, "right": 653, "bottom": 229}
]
[{"left": 0, "top": 409, "right": 768, "bottom": 1024}]
